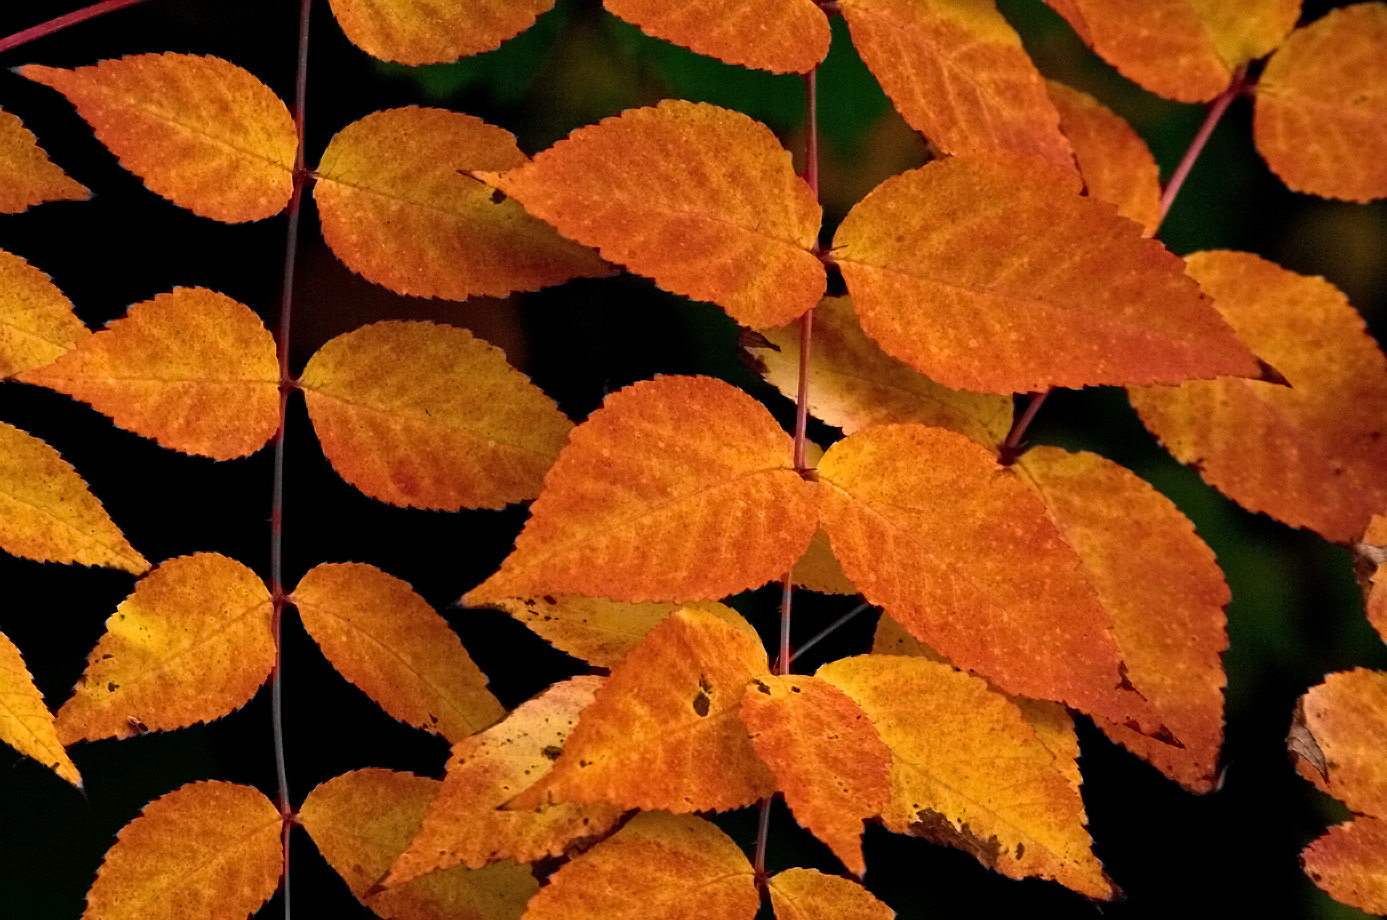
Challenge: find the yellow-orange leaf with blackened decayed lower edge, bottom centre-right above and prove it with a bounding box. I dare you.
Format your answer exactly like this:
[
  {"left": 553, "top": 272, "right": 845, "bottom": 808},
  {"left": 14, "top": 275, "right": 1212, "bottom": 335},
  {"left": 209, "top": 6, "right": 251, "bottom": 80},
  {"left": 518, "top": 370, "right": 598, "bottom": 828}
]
[{"left": 818, "top": 655, "right": 1115, "bottom": 899}]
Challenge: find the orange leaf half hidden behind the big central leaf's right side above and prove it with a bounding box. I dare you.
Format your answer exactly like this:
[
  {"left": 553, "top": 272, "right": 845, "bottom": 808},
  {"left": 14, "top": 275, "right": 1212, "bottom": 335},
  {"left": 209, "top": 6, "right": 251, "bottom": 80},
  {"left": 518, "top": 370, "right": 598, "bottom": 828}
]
[{"left": 1017, "top": 447, "right": 1230, "bottom": 792}]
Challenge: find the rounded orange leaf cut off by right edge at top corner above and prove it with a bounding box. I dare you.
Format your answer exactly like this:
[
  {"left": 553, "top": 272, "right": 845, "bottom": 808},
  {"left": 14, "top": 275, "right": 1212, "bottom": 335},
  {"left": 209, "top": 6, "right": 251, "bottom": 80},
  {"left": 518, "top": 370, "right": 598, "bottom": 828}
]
[{"left": 1252, "top": 3, "right": 1387, "bottom": 201}]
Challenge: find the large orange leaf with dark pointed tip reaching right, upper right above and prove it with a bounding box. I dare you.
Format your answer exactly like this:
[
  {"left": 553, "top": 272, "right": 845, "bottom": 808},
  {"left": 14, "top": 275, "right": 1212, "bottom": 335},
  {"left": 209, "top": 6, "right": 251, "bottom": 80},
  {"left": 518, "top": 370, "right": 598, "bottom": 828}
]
[{"left": 834, "top": 157, "right": 1258, "bottom": 393}]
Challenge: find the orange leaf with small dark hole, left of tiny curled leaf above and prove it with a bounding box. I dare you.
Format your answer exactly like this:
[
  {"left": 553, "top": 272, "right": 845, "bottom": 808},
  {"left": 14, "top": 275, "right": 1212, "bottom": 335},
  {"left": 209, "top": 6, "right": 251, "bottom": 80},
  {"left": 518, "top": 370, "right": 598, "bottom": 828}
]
[{"left": 513, "top": 608, "right": 774, "bottom": 812}]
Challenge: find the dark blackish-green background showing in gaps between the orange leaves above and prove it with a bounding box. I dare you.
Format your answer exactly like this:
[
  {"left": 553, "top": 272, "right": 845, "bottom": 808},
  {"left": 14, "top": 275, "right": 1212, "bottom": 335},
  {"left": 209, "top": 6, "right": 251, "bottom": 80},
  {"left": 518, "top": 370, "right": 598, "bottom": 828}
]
[{"left": 0, "top": 0, "right": 1387, "bottom": 920}]
